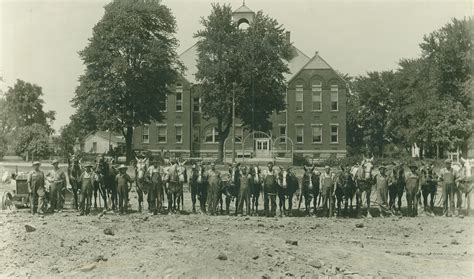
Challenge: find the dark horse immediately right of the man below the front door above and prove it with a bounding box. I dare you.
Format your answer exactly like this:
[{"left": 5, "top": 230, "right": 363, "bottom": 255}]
[{"left": 277, "top": 167, "right": 299, "bottom": 216}]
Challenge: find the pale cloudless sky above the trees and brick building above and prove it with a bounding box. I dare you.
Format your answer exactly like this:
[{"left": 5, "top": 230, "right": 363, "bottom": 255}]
[{"left": 0, "top": 0, "right": 474, "bottom": 130}]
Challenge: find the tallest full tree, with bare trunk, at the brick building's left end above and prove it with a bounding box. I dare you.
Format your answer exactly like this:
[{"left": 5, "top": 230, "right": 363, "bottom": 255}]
[{"left": 73, "top": 0, "right": 182, "bottom": 161}]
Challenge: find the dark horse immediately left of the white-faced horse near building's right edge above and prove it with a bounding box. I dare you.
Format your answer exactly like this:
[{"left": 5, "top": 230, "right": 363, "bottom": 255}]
[{"left": 334, "top": 167, "right": 356, "bottom": 216}]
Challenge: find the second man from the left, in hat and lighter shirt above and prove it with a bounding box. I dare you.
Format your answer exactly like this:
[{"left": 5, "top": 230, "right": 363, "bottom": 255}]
[{"left": 46, "top": 159, "right": 66, "bottom": 212}]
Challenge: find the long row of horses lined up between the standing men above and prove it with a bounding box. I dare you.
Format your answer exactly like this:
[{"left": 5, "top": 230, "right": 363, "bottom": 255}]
[{"left": 68, "top": 159, "right": 472, "bottom": 217}]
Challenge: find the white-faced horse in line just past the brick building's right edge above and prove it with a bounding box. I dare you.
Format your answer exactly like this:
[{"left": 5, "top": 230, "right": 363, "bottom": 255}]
[{"left": 351, "top": 158, "right": 375, "bottom": 218}]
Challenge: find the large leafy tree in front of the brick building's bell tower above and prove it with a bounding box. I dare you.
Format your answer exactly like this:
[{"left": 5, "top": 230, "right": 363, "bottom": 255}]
[{"left": 195, "top": 4, "right": 293, "bottom": 161}]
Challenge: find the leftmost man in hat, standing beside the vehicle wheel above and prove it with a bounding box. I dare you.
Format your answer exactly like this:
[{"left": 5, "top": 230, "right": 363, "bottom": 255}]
[{"left": 27, "top": 161, "right": 46, "bottom": 215}]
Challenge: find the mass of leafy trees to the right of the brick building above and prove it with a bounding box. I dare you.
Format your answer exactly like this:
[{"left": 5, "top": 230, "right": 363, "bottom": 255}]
[{"left": 348, "top": 18, "right": 474, "bottom": 156}]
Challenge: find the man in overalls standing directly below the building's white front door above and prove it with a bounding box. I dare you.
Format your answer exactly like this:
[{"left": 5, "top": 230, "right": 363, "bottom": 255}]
[{"left": 263, "top": 162, "right": 278, "bottom": 217}]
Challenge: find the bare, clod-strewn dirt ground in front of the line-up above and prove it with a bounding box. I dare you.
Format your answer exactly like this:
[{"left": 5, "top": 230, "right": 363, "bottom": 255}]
[{"left": 0, "top": 165, "right": 474, "bottom": 278}]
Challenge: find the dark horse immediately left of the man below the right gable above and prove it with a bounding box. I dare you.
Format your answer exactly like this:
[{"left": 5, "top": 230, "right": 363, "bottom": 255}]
[{"left": 298, "top": 166, "right": 320, "bottom": 216}]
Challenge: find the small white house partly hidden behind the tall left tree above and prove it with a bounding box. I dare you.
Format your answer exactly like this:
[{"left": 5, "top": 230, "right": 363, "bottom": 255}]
[{"left": 81, "top": 131, "right": 125, "bottom": 154}]
